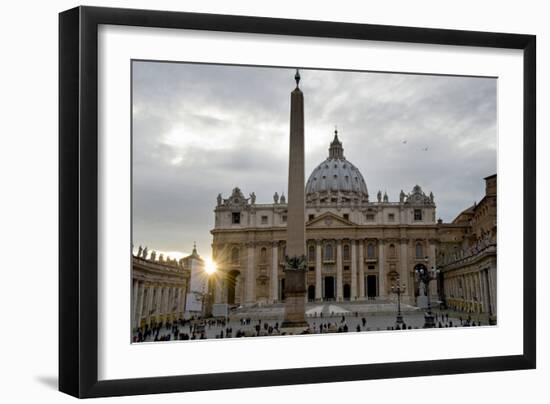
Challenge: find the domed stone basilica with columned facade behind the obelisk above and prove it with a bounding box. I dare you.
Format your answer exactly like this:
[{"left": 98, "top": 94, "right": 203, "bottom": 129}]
[{"left": 211, "top": 132, "right": 439, "bottom": 306}]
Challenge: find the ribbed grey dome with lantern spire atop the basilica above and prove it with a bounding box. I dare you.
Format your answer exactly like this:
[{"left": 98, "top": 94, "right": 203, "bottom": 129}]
[{"left": 306, "top": 131, "right": 369, "bottom": 202}]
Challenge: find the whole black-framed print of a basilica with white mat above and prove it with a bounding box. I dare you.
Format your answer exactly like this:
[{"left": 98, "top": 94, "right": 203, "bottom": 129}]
[{"left": 59, "top": 7, "right": 536, "bottom": 397}]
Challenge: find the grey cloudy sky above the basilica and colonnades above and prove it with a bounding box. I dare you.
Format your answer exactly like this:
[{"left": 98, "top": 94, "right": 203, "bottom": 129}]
[{"left": 132, "top": 61, "right": 497, "bottom": 257}]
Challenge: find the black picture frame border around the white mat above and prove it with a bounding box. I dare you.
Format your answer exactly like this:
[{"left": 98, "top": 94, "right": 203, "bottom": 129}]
[{"left": 59, "top": 7, "right": 536, "bottom": 398}]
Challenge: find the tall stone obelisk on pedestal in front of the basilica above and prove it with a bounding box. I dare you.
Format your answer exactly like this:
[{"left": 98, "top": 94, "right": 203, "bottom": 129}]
[{"left": 281, "top": 70, "right": 308, "bottom": 333}]
